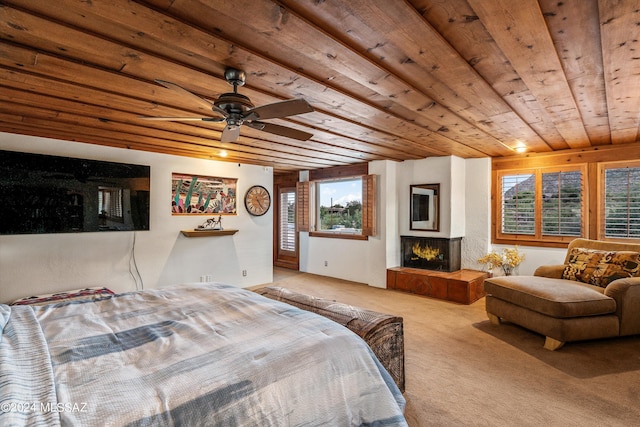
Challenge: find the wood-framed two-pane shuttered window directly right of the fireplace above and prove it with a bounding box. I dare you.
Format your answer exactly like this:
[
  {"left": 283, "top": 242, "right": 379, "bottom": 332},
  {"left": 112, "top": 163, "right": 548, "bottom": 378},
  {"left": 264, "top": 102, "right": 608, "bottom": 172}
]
[{"left": 496, "top": 167, "right": 585, "bottom": 241}]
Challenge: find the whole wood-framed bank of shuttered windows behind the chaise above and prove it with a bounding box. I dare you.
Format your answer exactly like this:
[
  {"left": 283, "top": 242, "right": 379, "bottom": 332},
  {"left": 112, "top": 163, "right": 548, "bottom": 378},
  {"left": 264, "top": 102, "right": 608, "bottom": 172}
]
[{"left": 492, "top": 144, "right": 640, "bottom": 247}]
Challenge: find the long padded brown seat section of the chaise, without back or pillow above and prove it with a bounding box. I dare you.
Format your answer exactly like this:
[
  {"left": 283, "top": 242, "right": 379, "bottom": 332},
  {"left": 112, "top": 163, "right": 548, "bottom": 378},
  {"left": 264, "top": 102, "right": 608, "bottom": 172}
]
[{"left": 484, "top": 276, "right": 619, "bottom": 350}]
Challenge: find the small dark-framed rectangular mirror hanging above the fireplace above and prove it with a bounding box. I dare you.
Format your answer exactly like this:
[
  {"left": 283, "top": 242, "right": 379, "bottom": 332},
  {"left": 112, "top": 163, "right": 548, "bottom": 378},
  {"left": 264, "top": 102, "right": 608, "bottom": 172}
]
[{"left": 409, "top": 184, "right": 440, "bottom": 231}]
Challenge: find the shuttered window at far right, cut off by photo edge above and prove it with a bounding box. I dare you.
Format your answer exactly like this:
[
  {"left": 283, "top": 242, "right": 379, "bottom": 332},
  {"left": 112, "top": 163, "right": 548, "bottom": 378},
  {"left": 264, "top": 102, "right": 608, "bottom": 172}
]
[{"left": 600, "top": 162, "right": 640, "bottom": 239}]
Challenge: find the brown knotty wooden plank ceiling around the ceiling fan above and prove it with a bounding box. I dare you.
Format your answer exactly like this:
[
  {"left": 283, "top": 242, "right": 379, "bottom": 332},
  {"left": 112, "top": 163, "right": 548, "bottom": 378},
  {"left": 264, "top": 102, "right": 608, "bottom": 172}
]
[{"left": 0, "top": 0, "right": 640, "bottom": 173}]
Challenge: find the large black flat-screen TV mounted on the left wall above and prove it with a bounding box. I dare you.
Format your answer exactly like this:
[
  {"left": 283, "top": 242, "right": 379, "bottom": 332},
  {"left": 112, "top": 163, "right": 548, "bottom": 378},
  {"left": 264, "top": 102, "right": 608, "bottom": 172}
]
[{"left": 0, "top": 151, "right": 151, "bottom": 234}]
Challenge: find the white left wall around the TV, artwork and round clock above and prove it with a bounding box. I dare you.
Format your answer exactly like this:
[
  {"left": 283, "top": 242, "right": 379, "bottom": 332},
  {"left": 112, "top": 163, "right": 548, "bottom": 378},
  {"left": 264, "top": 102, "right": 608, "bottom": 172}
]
[{"left": 0, "top": 133, "right": 273, "bottom": 302}]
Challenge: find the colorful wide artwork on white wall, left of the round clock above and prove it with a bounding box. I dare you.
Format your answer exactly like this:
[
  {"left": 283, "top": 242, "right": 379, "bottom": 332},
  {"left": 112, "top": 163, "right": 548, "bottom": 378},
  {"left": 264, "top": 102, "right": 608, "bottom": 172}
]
[{"left": 171, "top": 173, "right": 238, "bottom": 215}]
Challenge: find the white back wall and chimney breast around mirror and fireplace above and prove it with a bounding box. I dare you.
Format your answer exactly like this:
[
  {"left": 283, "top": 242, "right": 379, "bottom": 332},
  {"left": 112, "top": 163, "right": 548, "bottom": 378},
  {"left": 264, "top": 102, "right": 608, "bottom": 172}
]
[{"left": 300, "top": 157, "right": 500, "bottom": 288}]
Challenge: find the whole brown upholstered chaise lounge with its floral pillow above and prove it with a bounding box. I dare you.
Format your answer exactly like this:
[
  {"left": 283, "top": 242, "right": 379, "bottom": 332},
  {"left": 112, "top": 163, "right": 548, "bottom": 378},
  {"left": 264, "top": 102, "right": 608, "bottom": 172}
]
[{"left": 484, "top": 239, "right": 640, "bottom": 350}]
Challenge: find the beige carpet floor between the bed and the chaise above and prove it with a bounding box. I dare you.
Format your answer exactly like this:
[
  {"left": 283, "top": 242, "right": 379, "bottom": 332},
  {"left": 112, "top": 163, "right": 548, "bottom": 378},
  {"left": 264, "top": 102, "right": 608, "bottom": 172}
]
[{"left": 260, "top": 269, "right": 640, "bottom": 427}]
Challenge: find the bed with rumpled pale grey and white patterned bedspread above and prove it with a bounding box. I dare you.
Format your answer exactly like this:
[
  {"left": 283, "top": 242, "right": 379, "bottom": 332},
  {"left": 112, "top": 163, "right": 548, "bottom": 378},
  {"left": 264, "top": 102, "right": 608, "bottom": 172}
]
[{"left": 0, "top": 283, "right": 407, "bottom": 426}]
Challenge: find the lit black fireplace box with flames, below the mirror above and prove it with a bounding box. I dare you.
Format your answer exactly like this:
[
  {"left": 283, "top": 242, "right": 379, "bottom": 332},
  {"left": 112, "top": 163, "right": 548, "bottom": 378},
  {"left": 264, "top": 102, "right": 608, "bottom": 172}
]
[{"left": 400, "top": 236, "right": 462, "bottom": 272}]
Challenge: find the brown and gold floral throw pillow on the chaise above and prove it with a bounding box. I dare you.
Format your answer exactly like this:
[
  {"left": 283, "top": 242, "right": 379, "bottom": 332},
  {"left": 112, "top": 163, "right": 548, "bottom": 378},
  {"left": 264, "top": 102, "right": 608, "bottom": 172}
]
[{"left": 562, "top": 248, "right": 640, "bottom": 288}]
